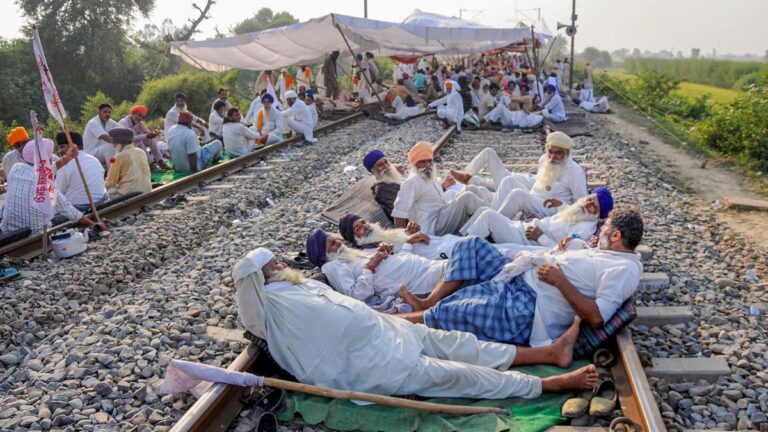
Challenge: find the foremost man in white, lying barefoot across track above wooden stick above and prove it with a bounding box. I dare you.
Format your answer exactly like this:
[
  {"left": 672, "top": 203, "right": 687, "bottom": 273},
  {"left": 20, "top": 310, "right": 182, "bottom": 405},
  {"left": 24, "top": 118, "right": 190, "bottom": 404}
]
[{"left": 232, "top": 248, "right": 597, "bottom": 399}]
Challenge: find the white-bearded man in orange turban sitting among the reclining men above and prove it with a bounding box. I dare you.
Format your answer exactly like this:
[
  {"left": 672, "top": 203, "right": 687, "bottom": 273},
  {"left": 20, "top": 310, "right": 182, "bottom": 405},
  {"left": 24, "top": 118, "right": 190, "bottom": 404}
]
[{"left": 392, "top": 141, "right": 486, "bottom": 235}]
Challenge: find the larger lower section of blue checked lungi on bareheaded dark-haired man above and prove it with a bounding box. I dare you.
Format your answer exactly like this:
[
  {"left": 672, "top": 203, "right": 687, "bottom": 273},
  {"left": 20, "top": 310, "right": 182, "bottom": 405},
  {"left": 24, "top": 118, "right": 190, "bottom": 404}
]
[{"left": 424, "top": 275, "right": 536, "bottom": 345}]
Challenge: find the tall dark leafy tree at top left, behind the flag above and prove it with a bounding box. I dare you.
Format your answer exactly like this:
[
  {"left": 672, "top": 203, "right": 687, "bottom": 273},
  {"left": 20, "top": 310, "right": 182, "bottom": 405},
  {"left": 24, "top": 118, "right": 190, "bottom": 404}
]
[{"left": 17, "top": 0, "right": 155, "bottom": 118}]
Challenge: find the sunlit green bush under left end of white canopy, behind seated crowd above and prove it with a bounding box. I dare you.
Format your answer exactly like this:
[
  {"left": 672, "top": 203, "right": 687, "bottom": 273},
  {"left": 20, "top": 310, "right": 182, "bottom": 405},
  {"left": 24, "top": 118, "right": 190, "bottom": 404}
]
[{"left": 137, "top": 72, "right": 221, "bottom": 118}]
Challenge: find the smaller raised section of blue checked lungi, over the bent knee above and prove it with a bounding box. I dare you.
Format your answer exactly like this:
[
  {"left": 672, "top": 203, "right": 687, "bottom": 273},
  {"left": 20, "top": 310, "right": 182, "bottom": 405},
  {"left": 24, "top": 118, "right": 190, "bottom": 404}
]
[{"left": 443, "top": 237, "right": 512, "bottom": 285}]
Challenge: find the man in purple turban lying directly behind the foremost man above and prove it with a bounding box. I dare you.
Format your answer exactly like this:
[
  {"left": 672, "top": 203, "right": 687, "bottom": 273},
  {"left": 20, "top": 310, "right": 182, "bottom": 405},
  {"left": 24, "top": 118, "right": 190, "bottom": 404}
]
[{"left": 306, "top": 229, "right": 447, "bottom": 309}]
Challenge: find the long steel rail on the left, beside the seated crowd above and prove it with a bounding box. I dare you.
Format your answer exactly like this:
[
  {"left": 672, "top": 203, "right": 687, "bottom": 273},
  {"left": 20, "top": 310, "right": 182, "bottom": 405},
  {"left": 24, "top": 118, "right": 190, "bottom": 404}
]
[{"left": 0, "top": 112, "right": 365, "bottom": 259}]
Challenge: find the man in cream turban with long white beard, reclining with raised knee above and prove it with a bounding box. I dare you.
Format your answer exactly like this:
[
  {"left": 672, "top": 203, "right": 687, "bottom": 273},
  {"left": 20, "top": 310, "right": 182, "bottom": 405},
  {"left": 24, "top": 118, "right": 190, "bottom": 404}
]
[{"left": 451, "top": 132, "right": 587, "bottom": 219}]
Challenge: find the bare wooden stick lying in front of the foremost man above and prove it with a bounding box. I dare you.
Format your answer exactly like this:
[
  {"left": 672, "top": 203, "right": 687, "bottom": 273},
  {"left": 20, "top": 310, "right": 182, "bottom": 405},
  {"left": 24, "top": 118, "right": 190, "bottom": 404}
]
[{"left": 264, "top": 377, "right": 509, "bottom": 416}]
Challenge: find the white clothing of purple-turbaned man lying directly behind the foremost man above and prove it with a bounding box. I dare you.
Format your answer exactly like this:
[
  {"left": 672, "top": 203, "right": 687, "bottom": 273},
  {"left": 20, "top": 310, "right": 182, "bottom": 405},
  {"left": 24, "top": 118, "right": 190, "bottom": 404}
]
[{"left": 322, "top": 249, "right": 448, "bottom": 304}]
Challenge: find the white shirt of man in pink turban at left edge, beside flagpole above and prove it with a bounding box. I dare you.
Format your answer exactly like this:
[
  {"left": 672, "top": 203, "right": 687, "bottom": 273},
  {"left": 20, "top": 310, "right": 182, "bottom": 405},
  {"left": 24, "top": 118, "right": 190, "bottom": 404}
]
[{"left": 0, "top": 162, "right": 83, "bottom": 234}]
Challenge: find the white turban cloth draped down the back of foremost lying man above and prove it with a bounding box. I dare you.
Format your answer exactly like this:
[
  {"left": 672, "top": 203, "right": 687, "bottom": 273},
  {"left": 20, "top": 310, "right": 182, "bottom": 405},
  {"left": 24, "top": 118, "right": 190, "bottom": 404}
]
[{"left": 232, "top": 248, "right": 275, "bottom": 339}]
